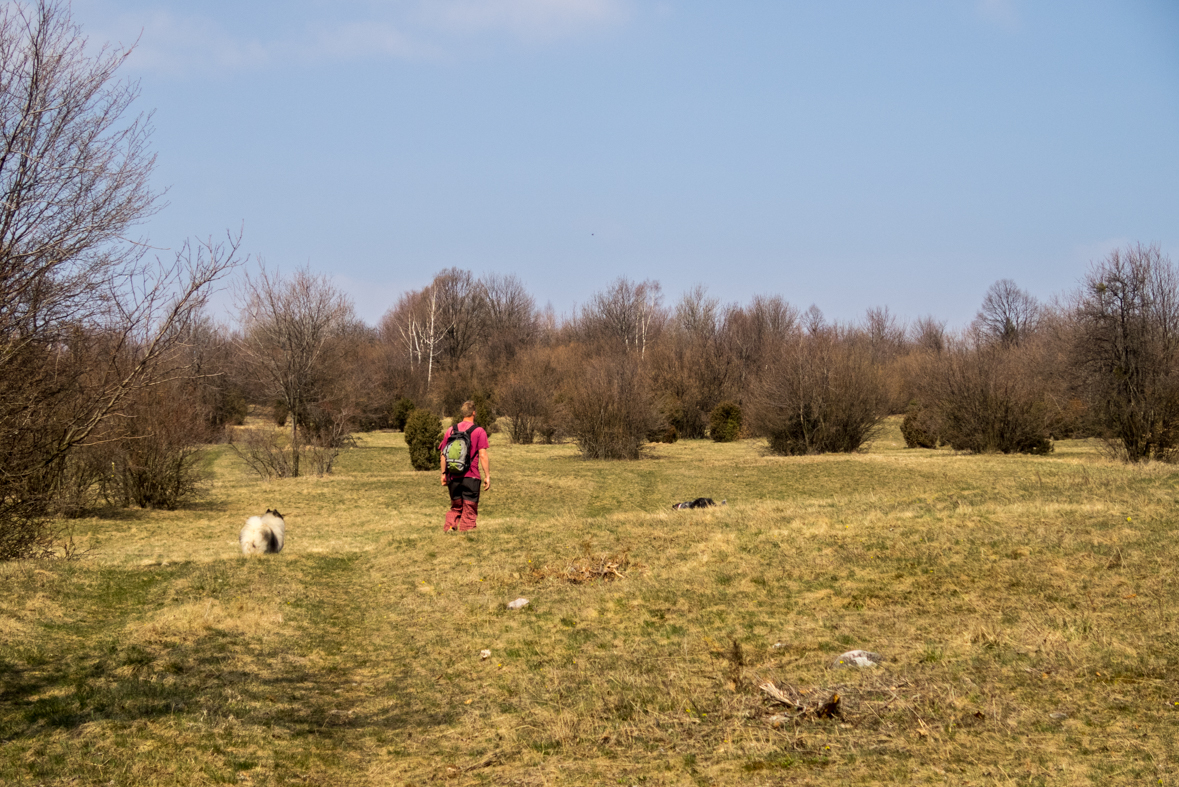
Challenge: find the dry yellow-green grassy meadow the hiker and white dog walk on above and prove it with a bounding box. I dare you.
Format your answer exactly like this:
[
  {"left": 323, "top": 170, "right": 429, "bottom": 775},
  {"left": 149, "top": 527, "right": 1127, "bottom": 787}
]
[{"left": 0, "top": 414, "right": 1179, "bottom": 787}]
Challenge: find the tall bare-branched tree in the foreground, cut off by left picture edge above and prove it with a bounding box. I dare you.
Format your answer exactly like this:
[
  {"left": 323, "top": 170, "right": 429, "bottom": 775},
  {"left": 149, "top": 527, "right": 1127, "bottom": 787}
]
[{"left": 0, "top": 0, "right": 237, "bottom": 558}]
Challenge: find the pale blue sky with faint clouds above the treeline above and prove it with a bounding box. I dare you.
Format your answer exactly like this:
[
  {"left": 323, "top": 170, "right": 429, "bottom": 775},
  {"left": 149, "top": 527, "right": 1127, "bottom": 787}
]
[{"left": 73, "top": 0, "right": 1179, "bottom": 326}]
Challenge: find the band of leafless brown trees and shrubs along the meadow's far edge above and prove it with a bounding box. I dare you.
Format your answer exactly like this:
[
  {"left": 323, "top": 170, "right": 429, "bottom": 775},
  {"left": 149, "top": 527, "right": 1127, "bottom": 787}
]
[{"left": 222, "top": 246, "right": 1179, "bottom": 461}]
